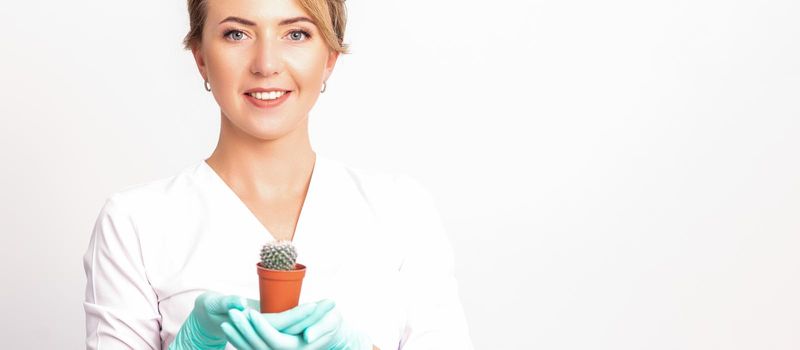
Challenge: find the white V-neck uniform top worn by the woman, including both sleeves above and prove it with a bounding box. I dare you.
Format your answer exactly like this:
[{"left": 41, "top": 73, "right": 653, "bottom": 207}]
[{"left": 83, "top": 152, "right": 472, "bottom": 350}]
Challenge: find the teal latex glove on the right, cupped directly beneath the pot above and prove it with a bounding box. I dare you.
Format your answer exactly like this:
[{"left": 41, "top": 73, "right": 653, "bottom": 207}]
[{"left": 221, "top": 299, "right": 372, "bottom": 350}]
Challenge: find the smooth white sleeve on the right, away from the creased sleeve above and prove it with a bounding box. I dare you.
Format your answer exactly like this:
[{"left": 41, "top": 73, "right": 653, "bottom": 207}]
[{"left": 399, "top": 175, "right": 473, "bottom": 350}]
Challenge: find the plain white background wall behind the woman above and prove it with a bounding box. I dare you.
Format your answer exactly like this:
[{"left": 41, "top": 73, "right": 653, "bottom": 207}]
[{"left": 0, "top": 0, "right": 800, "bottom": 350}]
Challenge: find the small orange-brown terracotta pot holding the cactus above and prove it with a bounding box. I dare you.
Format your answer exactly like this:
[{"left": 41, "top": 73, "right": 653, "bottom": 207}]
[{"left": 256, "top": 262, "right": 306, "bottom": 313}]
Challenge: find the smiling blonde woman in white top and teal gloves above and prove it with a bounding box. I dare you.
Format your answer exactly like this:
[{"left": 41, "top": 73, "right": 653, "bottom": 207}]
[{"left": 84, "top": 0, "right": 472, "bottom": 350}]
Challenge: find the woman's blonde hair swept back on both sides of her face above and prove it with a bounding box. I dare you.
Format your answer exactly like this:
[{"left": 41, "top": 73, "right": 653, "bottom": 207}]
[{"left": 183, "top": 0, "right": 350, "bottom": 54}]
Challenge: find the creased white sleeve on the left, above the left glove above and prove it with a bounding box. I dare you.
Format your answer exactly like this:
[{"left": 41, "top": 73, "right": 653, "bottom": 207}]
[{"left": 83, "top": 195, "right": 161, "bottom": 350}]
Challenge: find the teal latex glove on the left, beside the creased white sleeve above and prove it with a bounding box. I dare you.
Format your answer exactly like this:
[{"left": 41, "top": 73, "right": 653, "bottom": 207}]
[{"left": 169, "top": 292, "right": 246, "bottom": 350}]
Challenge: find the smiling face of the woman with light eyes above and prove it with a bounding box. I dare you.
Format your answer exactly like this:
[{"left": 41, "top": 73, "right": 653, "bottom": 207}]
[{"left": 193, "top": 0, "right": 339, "bottom": 139}]
